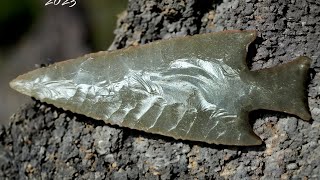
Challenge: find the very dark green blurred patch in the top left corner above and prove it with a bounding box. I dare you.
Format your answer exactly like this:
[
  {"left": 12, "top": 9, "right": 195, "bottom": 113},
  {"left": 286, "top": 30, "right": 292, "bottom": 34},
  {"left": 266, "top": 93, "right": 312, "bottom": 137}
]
[{"left": 0, "top": 0, "right": 43, "bottom": 49}]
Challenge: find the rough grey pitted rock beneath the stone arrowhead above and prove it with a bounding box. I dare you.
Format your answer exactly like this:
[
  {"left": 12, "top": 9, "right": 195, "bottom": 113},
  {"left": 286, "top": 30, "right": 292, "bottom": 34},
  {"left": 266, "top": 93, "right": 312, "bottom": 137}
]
[{"left": 0, "top": 0, "right": 320, "bottom": 179}]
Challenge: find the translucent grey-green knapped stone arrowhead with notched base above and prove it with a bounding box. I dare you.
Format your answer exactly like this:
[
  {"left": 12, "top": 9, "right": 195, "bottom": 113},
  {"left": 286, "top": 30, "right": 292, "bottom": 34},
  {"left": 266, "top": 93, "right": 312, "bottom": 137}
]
[{"left": 10, "top": 31, "right": 310, "bottom": 145}]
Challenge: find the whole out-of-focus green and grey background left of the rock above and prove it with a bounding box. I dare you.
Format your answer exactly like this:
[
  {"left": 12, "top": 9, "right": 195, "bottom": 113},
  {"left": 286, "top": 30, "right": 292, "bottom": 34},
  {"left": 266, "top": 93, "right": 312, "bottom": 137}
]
[{"left": 0, "top": 0, "right": 127, "bottom": 124}]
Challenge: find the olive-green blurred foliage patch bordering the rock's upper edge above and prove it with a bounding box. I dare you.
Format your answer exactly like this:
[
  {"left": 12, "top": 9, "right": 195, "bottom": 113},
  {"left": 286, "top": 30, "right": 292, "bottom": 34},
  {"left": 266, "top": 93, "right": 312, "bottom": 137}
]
[{"left": 81, "top": 0, "right": 128, "bottom": 51}]
